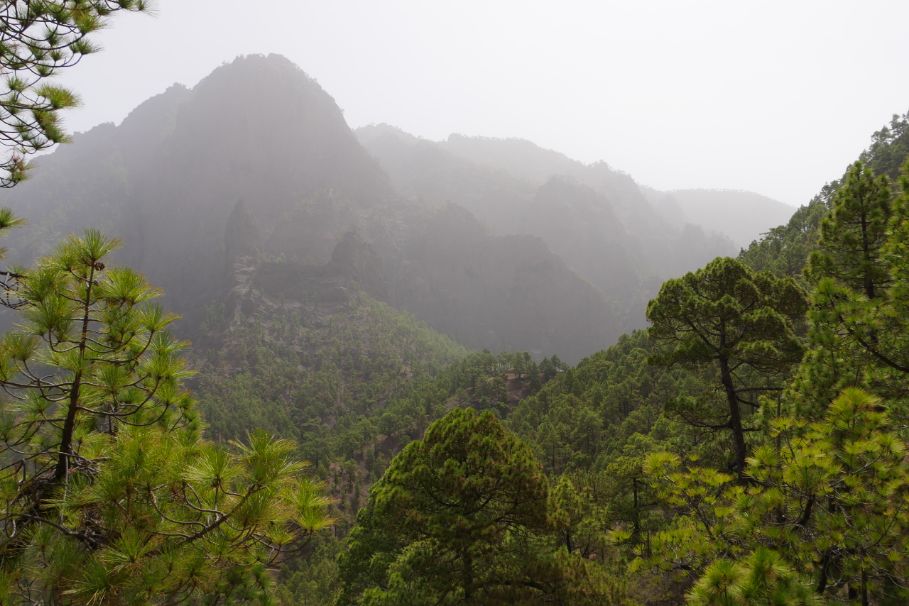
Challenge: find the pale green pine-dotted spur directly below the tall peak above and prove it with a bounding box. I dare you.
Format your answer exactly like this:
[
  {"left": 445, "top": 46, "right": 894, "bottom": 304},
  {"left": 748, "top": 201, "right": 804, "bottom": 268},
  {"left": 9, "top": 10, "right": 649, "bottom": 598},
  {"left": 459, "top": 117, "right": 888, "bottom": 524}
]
[{"left": 194, "top": 256, "right": 468, "bottom": 463}]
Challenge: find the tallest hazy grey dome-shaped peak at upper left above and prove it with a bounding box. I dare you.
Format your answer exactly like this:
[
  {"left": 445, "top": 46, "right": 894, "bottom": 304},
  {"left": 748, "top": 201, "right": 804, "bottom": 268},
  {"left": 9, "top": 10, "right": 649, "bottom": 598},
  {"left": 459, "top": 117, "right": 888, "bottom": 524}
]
[{"left": 8, "top": 56, "right": 391, "bottom": 319}]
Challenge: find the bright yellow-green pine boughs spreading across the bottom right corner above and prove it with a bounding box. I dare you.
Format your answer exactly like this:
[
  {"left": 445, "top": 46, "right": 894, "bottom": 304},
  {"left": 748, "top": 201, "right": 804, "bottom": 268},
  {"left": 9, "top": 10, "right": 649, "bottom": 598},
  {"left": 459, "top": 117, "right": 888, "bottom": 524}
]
[{"left": 644, "top": 388, "right": 909, "bottom": 604}]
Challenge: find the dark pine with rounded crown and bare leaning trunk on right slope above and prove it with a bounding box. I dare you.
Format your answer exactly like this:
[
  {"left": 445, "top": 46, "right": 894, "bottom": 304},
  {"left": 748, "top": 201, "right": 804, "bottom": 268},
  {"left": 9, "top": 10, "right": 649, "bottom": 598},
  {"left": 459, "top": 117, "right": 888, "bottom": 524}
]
[{"left": 647, "top": 259, "right": 807, "bottom": 473}]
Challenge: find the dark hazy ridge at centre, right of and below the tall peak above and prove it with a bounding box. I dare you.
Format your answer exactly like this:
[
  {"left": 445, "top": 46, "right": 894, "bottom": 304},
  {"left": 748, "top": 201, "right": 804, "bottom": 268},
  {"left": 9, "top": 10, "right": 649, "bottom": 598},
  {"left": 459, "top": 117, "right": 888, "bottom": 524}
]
[{"left": 387, "top": 205, "right": 620, "bottom": 360}]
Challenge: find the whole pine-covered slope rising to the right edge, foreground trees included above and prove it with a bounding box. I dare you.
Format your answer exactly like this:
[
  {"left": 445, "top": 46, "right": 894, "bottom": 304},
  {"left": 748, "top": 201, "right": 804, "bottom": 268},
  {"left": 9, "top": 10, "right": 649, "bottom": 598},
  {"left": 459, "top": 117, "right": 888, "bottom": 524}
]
[{"left": 282, "top": 110, "right": 909, "bottom": 604}]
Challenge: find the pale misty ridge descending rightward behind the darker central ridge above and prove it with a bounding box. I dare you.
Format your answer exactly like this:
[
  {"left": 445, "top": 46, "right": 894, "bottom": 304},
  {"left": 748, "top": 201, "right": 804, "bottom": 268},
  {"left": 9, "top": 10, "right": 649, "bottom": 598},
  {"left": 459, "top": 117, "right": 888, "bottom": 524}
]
[{"left": 356, "top": 124, "right": 735, "bottom": 330}]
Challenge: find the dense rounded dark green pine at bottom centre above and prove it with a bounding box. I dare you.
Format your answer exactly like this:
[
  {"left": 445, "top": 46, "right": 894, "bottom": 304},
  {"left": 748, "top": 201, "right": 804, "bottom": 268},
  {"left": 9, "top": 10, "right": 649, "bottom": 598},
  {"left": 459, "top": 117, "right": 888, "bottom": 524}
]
[{"left": 339, "top": 408, "right": 626, "bottom": 606}]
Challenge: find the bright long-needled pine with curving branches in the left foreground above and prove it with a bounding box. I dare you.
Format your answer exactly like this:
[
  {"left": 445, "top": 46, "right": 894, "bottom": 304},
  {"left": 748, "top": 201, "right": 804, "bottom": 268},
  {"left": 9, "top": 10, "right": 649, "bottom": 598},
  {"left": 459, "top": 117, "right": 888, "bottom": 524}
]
[{"left": 0, "top": 231, "right": 329, "bottom": 604}]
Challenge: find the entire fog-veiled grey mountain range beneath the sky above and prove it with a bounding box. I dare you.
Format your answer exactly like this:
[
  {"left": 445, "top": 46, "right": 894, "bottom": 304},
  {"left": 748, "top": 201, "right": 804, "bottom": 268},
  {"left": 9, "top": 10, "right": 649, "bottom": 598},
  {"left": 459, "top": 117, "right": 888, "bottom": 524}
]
[{"left": 5, "top": 55, "right": 791, "bottom": 360}]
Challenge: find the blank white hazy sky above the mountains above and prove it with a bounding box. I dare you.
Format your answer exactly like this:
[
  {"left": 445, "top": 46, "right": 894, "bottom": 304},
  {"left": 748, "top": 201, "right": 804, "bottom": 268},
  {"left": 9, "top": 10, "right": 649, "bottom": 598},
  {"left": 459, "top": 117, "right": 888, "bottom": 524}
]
[{"left": 55, "top": 0, "right": 909, "bottom": 204}]
